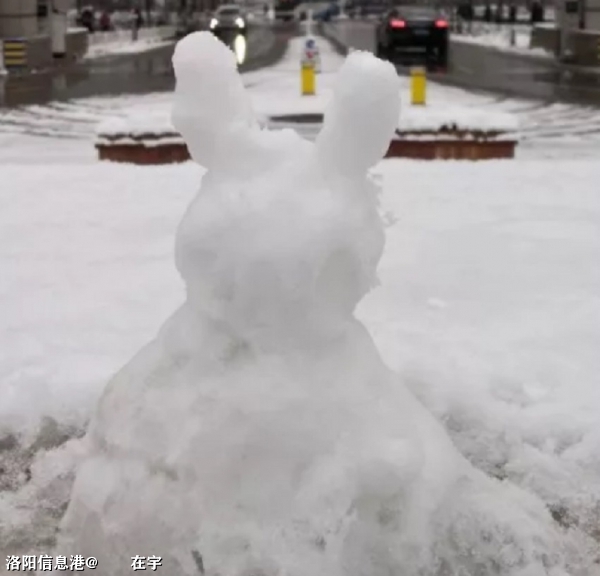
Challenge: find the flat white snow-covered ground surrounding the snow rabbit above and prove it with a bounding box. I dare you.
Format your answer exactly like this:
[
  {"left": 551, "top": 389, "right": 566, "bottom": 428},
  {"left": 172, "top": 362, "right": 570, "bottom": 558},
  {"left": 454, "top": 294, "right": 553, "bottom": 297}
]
[{"left": 0, "top": 36, "right": 600, "bottom": 576}]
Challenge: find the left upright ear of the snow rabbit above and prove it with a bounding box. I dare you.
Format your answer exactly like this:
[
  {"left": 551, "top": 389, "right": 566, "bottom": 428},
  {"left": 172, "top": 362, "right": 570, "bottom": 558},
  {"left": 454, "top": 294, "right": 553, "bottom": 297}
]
[{"left": 171, "top": 32, "right": 254, "bottom": 168}]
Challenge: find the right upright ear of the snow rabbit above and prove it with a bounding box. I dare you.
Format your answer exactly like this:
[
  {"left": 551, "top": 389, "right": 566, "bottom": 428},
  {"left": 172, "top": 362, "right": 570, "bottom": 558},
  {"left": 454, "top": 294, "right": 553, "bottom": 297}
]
[{"left": 316, "top": 51, "right": 400, "bottom": 174}]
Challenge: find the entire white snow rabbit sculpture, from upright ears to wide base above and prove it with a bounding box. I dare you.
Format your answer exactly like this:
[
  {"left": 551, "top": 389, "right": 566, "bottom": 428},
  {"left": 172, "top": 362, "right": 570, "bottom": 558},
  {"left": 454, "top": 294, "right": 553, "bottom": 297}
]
[{"left": 57, "top": 33, "right": 589, "bottom": 576}]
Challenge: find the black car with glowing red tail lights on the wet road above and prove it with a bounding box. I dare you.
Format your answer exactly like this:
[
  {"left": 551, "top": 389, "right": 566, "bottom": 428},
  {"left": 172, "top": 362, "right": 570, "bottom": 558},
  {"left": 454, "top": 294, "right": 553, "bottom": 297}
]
[{"left": 375, "top": 6, "right": 449, "bottom": 70}]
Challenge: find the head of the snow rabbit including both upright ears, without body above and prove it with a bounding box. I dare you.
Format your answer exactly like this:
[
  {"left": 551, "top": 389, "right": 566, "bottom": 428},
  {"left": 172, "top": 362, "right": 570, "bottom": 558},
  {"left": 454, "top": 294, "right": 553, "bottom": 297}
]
[{"left": 172, "top": 32, "right": 400, "bottom": 348}]
